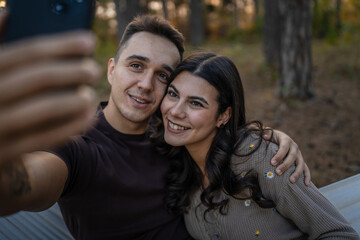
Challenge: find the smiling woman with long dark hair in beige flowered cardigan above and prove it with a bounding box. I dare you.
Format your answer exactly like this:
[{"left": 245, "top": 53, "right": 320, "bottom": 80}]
[{"left": 150, "top": 53, "right": 359, "bottom": 239}]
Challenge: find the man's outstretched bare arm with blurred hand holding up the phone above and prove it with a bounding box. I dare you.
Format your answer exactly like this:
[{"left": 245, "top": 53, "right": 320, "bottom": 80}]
[{"left": 0, "top": 14, "right": 100, "bottom": 215}]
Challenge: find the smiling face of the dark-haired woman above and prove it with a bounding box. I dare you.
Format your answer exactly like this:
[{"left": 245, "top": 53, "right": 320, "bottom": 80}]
[{"left": 161, "top": 71, "right": 221, "bottom": 154}]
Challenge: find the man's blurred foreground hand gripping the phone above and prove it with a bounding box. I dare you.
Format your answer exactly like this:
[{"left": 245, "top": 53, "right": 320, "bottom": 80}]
[{"left": 0, "top": 12, "right": 101, "bottom": 166}]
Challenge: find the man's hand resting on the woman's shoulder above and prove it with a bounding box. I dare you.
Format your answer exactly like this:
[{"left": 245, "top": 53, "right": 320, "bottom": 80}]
[{"left": 263, "top": 130, "right": 311, "bottom": 186}]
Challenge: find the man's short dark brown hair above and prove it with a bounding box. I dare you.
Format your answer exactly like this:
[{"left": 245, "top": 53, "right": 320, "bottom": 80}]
[{"left": 115, "top": 15, "right": 184, "bottom": 62}]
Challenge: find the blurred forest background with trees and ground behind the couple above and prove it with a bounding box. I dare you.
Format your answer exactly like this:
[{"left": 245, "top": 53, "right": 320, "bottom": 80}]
[{"left": 0, "top": 0, "right": 360, "bottom": 187}]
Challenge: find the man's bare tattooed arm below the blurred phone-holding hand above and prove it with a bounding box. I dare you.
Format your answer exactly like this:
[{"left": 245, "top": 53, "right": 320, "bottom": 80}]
[{"left": 0, "top": 152, "right": 68, "bottom": 216}]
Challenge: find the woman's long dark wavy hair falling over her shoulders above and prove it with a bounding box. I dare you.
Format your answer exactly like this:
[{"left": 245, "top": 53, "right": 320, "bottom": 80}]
[{"left": 150, "top": 53, "right": 274, "bottom": 217}]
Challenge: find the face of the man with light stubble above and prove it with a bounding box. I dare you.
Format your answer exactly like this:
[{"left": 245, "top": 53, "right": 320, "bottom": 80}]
[{"left": 105, "top": 32, "right": 180, "bottom": 133}]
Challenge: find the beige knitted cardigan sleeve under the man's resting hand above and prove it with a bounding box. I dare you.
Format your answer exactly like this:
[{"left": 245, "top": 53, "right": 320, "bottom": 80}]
[{"left": 254, "top": 141, "right": 359, "bottom": 239}]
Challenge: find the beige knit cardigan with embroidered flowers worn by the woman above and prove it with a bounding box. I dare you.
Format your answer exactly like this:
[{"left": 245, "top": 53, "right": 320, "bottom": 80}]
[{"left": 185, "top": 135, "right": 360, "bottom": 240}]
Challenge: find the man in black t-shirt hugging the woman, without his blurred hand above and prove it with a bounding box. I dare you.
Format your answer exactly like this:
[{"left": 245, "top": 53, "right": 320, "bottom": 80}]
[{"left": 0, "top": 16, "right": 309, "bottom": 239}]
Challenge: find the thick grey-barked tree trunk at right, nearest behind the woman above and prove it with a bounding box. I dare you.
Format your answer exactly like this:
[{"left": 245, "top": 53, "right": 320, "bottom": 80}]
[{"left": 277, "top": 0, "right": 314, "bottom": 99}]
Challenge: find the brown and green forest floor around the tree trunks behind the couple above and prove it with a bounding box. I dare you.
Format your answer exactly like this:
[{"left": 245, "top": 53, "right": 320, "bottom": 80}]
[{"left": 95, "top": 40, "right": 360, "bottom": 187}]
